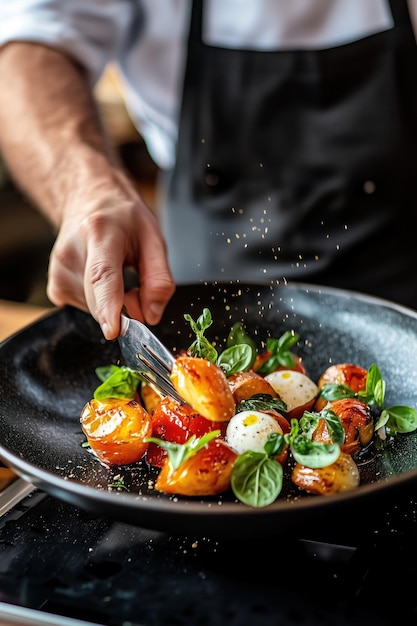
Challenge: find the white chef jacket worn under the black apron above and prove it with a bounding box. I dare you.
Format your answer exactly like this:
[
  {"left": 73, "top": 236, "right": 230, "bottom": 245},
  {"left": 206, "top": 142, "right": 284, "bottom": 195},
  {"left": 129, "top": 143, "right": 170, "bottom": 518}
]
[{"left": 0, "top": 0, "right": 417, "bottom": 168}]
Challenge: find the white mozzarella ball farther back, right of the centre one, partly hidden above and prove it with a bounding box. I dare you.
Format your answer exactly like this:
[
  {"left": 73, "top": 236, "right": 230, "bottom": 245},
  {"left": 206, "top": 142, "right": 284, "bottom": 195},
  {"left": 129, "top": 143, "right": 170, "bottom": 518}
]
[{"left": 265, "top": 370, "right": 319, "bottom": 413}]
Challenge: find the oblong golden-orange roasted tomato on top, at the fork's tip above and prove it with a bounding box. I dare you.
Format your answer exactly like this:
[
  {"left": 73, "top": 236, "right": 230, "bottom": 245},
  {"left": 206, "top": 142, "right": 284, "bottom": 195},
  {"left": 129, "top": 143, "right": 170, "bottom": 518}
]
[{"left": 171, "top": 356, "right": 236, "bottom": 422}]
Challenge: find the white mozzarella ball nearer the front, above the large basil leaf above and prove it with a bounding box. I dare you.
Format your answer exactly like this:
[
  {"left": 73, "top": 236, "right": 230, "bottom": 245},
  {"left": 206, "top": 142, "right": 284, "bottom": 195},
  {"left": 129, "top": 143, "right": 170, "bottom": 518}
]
[{"left": 225, "top": 411, "right": 282, "bottom": 454}]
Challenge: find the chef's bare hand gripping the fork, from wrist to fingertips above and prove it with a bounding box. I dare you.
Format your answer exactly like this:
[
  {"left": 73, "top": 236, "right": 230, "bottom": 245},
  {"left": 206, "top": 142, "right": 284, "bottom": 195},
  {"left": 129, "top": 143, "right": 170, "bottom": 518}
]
[{"left": 47, "top": 170, "right": 175, "bottom": 339}]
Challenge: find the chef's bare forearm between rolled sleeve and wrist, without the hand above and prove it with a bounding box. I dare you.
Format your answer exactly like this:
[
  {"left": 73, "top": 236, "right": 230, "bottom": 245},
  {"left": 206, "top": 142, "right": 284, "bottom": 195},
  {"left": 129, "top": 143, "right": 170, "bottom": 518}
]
[{"left": 0, "top": 43, "right": 114, "bottom": 226}]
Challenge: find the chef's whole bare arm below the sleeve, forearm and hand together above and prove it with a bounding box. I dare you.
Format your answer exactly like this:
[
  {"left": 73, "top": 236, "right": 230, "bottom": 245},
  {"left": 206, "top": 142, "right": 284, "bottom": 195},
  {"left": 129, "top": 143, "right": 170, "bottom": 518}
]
[{"left": 0, "top": 44, "right": 174, "bottom": 339}]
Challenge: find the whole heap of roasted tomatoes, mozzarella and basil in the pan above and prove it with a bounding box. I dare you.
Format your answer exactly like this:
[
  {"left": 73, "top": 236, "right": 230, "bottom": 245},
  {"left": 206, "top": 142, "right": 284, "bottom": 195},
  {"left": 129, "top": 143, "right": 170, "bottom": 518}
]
[{"left": 81, "top": 309, "right": 417, "bottom": 507}]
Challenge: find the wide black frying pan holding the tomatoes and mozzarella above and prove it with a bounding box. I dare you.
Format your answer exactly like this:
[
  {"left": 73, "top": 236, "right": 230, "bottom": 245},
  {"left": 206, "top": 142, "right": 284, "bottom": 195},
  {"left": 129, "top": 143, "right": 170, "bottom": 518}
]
[{"left": 0, "top": 284, "right": 417, "bottom": 537}]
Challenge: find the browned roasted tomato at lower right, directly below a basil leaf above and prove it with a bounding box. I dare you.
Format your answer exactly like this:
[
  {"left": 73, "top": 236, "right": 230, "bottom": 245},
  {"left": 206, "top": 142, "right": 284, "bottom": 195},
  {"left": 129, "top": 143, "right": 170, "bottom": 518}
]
[{"left": 291, "top": 452, "right": 360, "bottom": 496}]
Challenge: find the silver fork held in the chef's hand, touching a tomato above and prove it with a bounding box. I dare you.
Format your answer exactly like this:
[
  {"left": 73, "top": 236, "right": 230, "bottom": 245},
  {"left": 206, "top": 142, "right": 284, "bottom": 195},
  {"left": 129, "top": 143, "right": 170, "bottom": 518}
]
[{"left": 118, "top": 307, "right": 184, "bottom": 404}]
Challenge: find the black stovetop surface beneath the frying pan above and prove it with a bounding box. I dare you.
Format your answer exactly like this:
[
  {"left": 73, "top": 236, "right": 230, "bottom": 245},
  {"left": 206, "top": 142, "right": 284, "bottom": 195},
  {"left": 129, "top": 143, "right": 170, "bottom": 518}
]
[{"left": 0, "top": 491, "right": 417, "bottom": 626}]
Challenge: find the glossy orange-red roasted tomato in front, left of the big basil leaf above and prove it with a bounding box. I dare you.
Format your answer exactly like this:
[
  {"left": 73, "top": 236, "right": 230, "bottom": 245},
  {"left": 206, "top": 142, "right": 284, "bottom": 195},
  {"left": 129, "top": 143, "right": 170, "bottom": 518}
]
[{"left": 155, "top": 439, "right": 238, "bottom": 496}]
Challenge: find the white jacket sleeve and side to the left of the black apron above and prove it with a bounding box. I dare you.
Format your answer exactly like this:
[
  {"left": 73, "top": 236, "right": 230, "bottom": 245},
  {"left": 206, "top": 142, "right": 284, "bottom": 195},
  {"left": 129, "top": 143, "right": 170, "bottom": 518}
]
[{"left": 0, "top": 0, "right": 187, "bottom": 167}]
